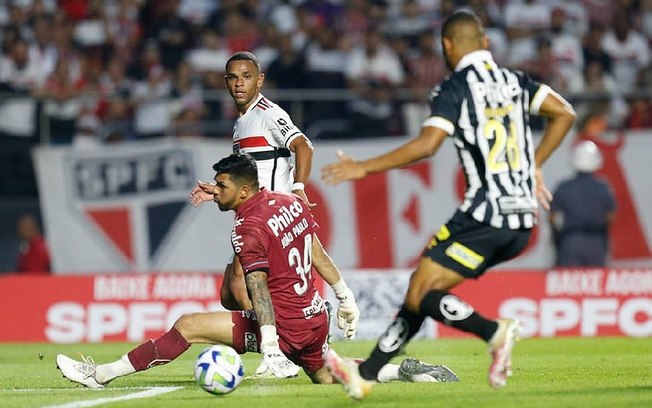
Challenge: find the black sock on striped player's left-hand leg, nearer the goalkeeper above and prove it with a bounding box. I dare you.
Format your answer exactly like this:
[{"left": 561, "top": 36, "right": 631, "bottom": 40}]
[{"left": 360, "top": 306, "right": 425, "bottom": 381}]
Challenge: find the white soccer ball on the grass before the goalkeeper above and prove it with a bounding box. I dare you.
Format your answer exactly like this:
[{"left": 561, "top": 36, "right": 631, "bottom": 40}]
[{"left": 195, "top": 344, "right": 244, "bottom": 395}]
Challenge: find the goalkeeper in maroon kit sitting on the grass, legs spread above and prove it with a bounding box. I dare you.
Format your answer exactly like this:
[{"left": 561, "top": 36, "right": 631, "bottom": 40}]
[{"left": 57, "top": 154, "right": 457, "bottom": 388}]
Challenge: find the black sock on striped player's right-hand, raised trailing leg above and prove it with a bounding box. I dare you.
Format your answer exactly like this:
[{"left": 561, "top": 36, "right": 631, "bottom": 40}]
[{"left": 420, "top": 290, "right": 498, "bottom": 341}]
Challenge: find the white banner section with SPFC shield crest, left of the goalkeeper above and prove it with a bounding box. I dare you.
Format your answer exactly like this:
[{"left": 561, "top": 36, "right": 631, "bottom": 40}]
[{"left": 35, "top": 141, "right": 233, "bottom": 272}]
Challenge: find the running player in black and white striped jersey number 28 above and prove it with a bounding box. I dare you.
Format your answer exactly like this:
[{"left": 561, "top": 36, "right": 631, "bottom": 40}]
[{"left": 322, "top": 11, "right": 575, "bottom": 398}]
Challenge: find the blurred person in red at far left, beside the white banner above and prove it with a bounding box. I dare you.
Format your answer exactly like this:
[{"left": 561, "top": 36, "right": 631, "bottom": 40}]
[{"left": 16, "top": 214, "right": 50, "bottom": 274}]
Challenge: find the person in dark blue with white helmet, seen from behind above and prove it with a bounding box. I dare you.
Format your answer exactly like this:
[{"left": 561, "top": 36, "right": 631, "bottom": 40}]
[{"left": 550, "top": 140, "right": 616, "bottom": 267}]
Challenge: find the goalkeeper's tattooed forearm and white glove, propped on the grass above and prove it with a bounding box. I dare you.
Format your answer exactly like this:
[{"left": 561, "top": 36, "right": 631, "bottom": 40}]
[{"left": 245, "top": 271, "right": 299, "bottom": 378}]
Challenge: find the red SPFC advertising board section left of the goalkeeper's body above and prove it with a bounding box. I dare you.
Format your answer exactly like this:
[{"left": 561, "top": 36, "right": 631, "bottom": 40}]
[{"left": 0, "top": 273, "right": 224, "bottom": 343}]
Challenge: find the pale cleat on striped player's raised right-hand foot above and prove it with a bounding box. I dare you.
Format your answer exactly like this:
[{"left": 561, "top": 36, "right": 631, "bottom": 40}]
[{"left": 489, "top": 319, "right": 522, "bottom": 388}]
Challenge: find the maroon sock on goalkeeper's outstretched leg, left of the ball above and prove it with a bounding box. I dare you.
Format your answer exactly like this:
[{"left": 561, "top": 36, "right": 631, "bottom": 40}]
[{"left": 127, "top": 327, "right": 190, "bottom": 371}]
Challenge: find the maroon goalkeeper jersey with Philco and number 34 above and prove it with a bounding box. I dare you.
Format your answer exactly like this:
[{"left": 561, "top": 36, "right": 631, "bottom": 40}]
[{"left": 231, "top": 189, "right": 325, "bottom": 330}]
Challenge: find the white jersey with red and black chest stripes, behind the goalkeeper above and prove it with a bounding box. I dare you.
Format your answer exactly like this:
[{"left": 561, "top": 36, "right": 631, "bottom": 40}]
[{"left": 233, "top": 94, "right": 303, "bottom": 192}]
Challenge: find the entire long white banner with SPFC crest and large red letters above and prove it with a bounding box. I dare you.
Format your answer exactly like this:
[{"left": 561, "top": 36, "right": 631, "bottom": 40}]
[{"left": 35, "top": 133, "right": 652, "bottom": 274}]
